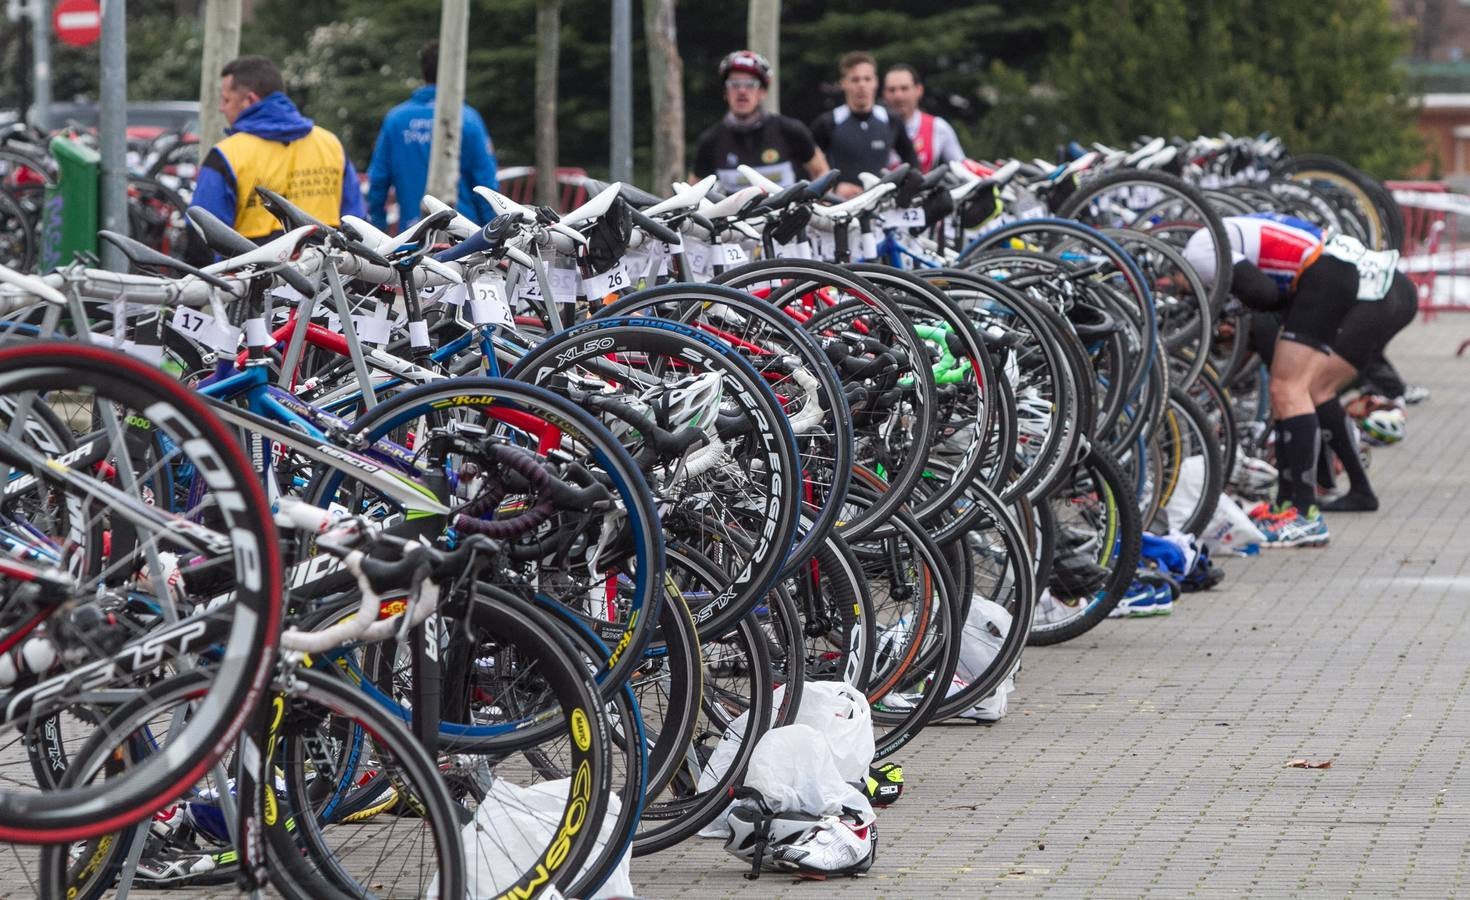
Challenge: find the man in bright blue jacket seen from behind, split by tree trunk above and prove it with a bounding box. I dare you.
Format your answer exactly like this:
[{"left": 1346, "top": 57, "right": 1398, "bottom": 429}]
[{"left": 368, "top": 41, "right": 500, "bottom": 231}]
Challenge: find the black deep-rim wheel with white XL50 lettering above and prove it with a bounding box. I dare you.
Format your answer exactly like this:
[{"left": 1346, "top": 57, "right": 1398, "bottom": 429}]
[{"left": 509, "top": 319, "right": 801, "bottom": 634}]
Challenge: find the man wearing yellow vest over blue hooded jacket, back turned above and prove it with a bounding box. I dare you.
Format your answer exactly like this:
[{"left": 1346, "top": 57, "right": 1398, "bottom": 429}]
[{"left": 193, "top": 56, "right": 368, "bottom": 243}]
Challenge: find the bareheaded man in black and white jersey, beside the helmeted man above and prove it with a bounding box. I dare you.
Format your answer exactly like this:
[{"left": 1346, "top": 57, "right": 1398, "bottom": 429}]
[{"left": 811, "top": 51, "right": 919, "bottom": 199}]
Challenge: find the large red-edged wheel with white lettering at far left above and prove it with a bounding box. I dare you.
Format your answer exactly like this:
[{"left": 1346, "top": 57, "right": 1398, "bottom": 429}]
[{"left": 0, "top": 343, "right": 282, "bottom": 843}]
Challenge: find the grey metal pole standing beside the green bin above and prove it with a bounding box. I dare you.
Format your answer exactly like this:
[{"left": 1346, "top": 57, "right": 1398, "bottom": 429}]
[{"left": 97, "top": 0, "right": 128, "bottom": 272}]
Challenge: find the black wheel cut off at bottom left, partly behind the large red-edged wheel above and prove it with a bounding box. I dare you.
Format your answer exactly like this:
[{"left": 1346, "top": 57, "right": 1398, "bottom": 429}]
[{"left": 40, "top": 671, "right": 465, "bottom": 899}]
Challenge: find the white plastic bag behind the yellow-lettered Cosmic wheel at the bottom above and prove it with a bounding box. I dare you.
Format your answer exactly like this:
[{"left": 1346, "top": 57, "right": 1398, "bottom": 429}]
[{"left": 441, "top": 778, "right": 634, "bottom": 900}]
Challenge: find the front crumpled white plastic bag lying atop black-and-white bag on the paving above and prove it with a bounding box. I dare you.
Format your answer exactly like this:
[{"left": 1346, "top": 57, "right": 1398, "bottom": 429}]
[{"left": 745, "top": 723, "right": 873, "bottom": 822}]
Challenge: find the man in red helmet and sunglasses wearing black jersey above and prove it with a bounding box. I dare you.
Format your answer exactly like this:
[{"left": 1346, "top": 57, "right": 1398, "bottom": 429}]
[{"left": 694, "top": 50, "right": 828, "bottom": 191}]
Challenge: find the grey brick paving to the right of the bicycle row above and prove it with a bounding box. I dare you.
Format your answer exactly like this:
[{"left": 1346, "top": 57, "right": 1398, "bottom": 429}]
[{"left": 0, "top": 316, "right": 1470, "bottom": 900}]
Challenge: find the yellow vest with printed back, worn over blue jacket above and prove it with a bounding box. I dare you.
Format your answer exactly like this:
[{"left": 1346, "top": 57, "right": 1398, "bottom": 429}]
[{"left": 215, "top": 126, "right": 344, "bottom": 240}]
